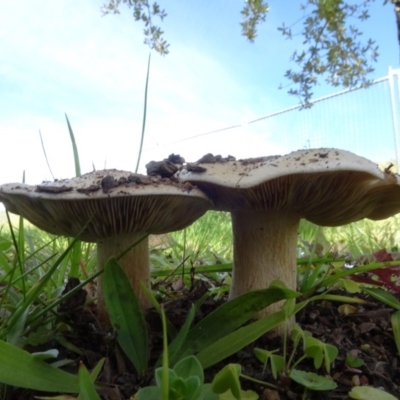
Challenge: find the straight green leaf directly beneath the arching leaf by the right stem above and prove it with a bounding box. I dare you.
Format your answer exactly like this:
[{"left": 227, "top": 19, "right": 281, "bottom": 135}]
[{"left": 196, "top": 311, "right": 286, "bottom": 368}]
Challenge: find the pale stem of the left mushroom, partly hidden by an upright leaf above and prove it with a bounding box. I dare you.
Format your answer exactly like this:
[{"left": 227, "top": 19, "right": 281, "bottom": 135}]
[{"left": 97, "top": 233, "right": 151, "bottom": 326}]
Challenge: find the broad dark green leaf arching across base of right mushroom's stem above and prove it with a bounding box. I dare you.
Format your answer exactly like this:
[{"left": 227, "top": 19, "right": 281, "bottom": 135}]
[{"left": 178, "top": 288, "right": 299, "bottom": 360}]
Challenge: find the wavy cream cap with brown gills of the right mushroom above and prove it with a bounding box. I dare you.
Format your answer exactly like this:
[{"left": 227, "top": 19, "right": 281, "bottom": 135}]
[{"left": 176, "top": 148, "right": 400, "bottom": 226}]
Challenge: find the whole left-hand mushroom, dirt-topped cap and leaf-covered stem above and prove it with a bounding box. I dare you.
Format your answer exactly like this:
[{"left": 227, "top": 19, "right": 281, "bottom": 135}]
[{"left": 0, "top": 170, "right": 211, "bottom": 324}]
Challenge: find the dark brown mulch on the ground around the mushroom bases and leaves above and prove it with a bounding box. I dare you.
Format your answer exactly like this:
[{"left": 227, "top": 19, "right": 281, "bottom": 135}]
[{"left": 5, "top": 280, "right": 400, "bottom": 400}]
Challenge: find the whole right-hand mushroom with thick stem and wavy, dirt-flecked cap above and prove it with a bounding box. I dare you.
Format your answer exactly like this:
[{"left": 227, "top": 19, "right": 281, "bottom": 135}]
[{"left": 176, "top": 148, "right": 400, "bottom": 316}]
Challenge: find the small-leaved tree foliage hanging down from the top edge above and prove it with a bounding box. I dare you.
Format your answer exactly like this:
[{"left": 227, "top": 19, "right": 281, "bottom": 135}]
[{"left": 102, "top": 0, "right": 400, "bottom": 107}]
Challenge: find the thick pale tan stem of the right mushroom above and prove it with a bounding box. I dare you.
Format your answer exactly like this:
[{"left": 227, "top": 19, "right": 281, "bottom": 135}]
[{"left": 230, "top": 210, "right": 300, "bottom": 317}]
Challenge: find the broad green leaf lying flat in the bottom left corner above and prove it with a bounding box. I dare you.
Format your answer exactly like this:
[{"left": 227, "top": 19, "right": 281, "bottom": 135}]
[{"left": 0, "top": 340, "right": 79, "bottom": 393}]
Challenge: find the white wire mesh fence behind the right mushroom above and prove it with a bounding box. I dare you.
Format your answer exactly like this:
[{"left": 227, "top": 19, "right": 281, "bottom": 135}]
[{"left": 144, "top": 68, "right": 400, "bottom": 162}]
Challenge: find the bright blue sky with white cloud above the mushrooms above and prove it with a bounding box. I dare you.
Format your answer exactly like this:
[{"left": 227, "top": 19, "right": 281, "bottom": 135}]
[{"left": 0, "top": 0, "right": 399, "bottom": 192}]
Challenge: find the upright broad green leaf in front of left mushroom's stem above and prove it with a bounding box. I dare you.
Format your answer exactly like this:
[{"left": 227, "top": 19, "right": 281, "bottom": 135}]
[{"left": 102, "top": 257, "right": 149, "bottom": 374}]
